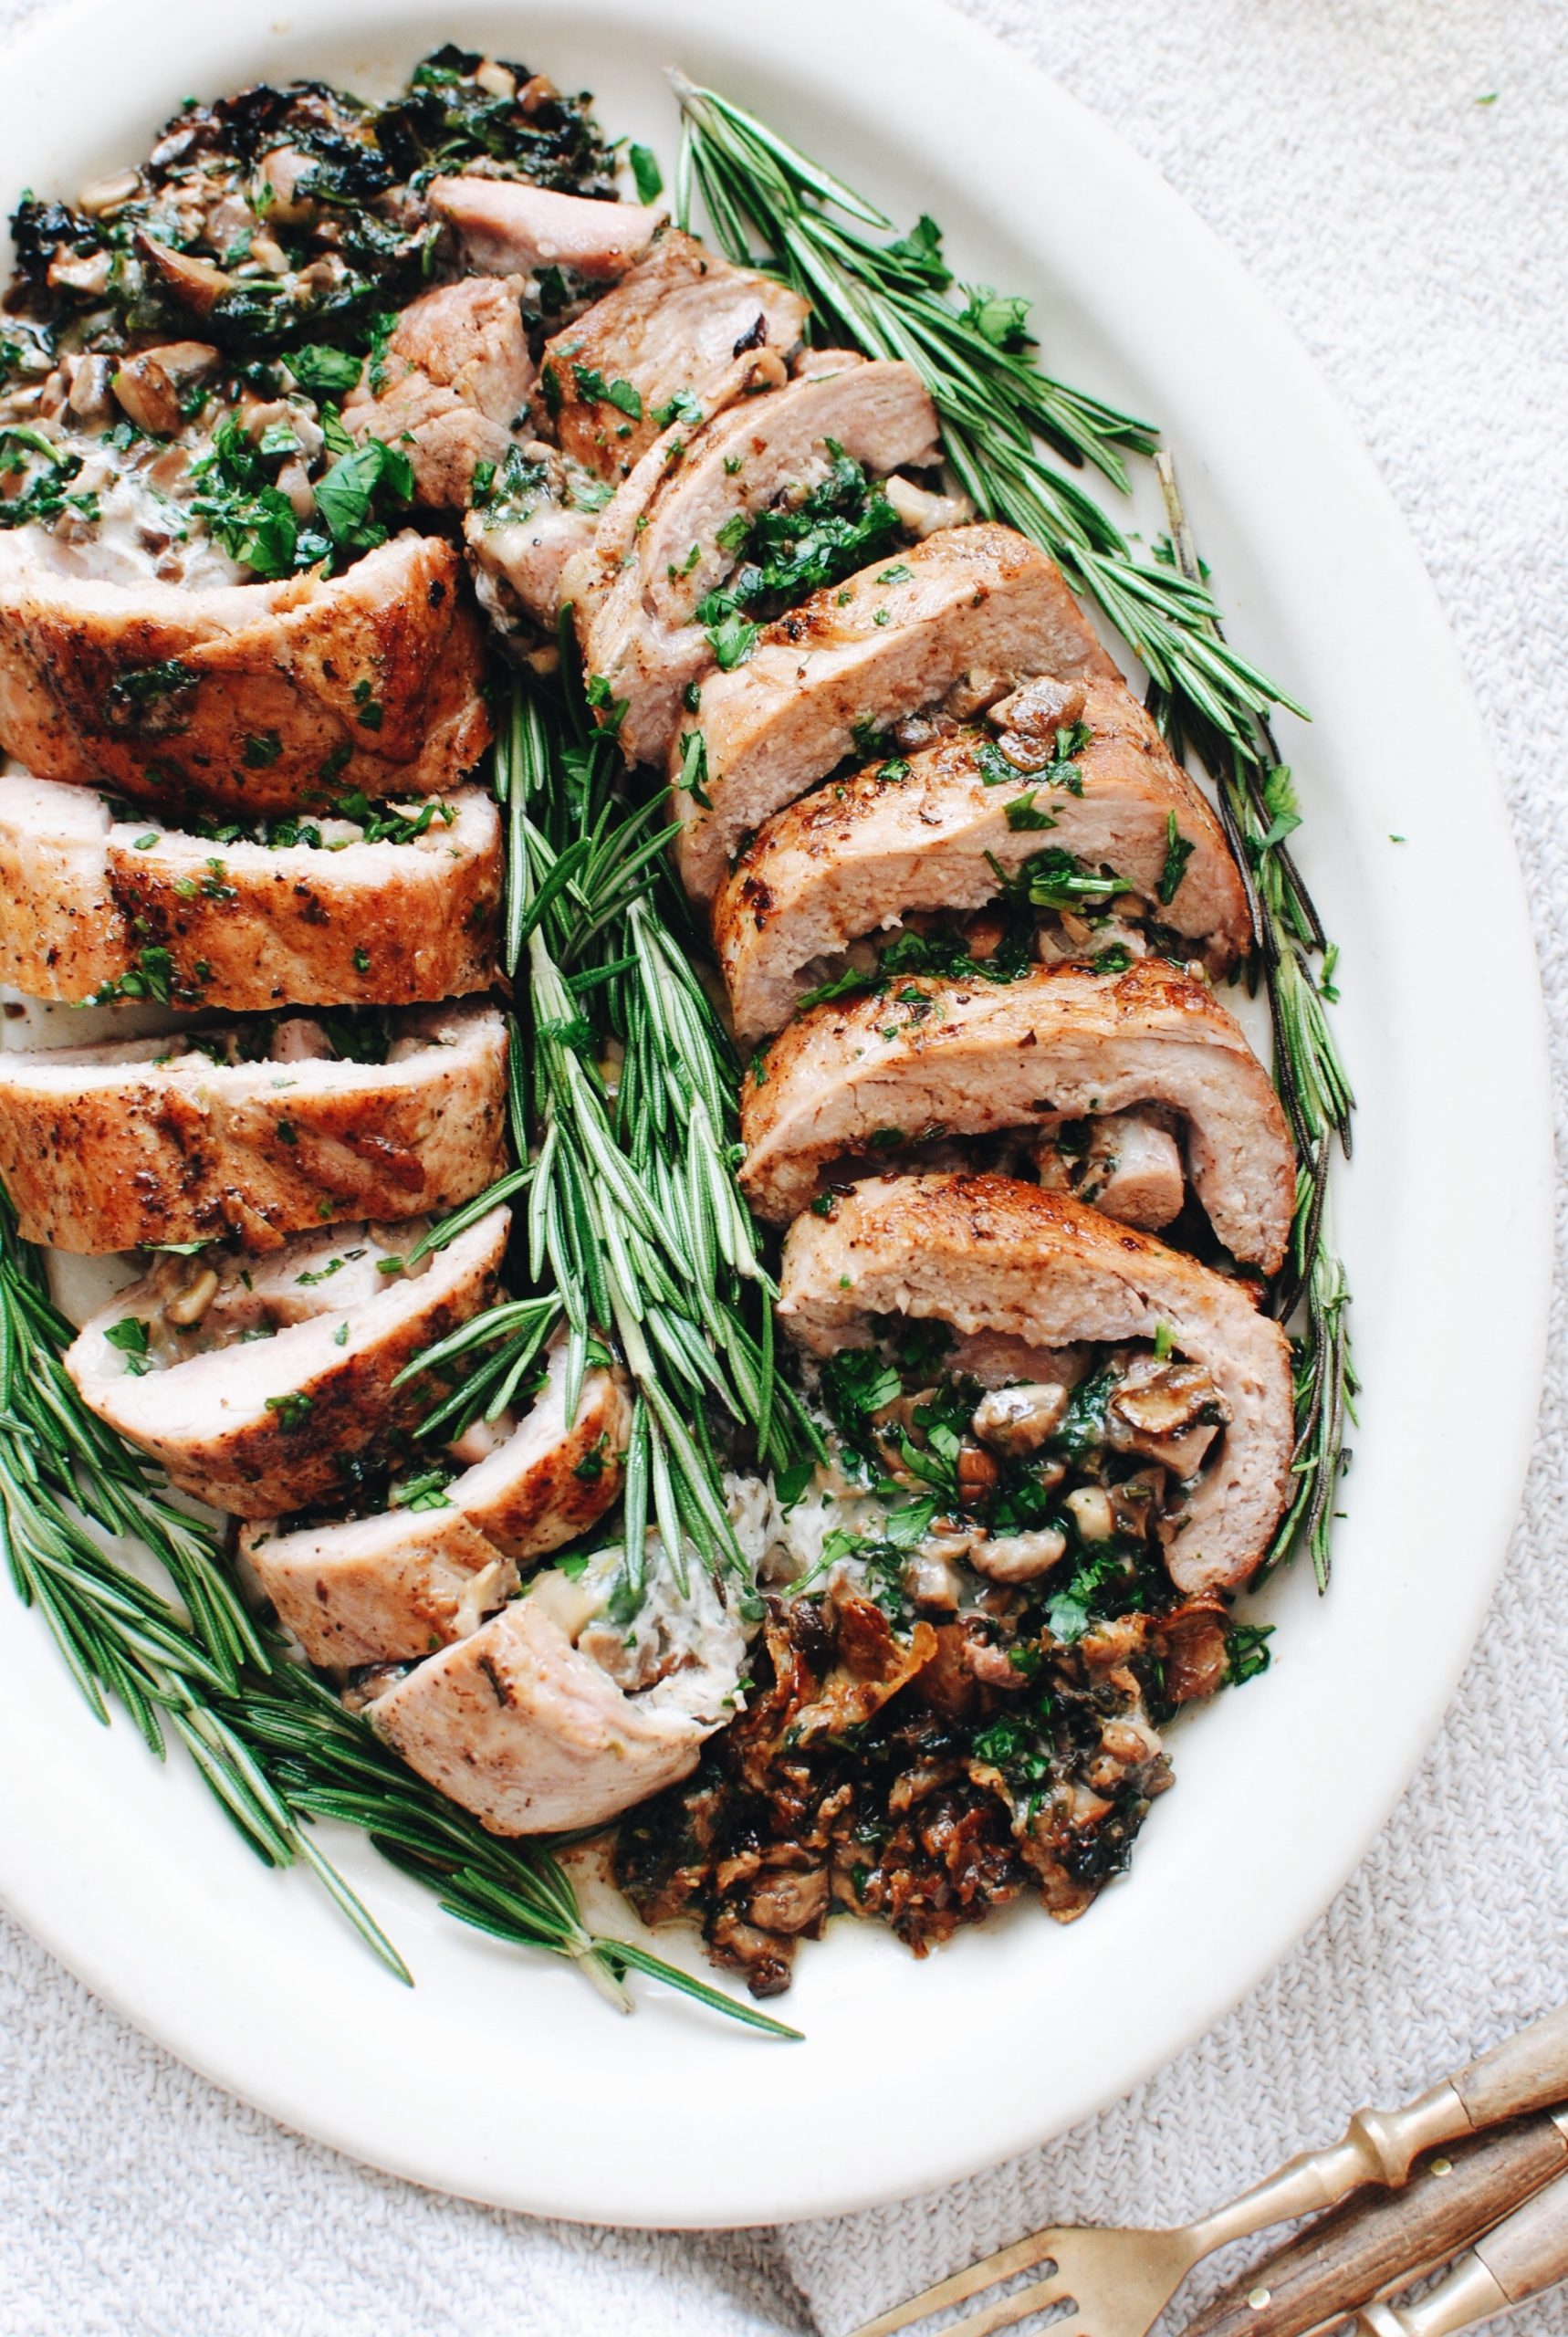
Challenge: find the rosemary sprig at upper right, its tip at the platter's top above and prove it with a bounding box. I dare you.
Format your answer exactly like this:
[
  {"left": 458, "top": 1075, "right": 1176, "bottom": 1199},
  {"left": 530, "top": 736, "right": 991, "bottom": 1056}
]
[{"left": 671, "top": 72, "right": 1301, "bottom": 750}]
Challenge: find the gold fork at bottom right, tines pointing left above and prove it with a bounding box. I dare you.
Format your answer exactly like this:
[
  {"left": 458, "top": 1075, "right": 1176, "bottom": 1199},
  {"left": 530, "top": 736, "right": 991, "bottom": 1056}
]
[{"left": 853, "top": 2005, "right": 1568, "bottom": 2337}]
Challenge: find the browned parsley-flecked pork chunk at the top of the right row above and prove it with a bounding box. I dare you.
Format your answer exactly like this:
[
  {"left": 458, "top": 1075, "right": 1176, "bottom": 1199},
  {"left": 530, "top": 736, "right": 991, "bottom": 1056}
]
[{"left": 539, "top": 229, "right": 806, "bottom": 481}]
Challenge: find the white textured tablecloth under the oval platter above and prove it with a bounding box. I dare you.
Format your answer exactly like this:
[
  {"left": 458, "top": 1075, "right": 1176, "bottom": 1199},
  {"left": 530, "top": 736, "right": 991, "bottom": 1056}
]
[{"left": 0, "top": 0, "right": 1568, "bottom": 2337}]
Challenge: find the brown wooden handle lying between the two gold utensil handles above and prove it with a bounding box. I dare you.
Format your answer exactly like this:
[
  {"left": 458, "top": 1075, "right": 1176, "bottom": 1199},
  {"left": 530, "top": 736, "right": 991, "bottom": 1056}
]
[{"left": 1185, "top": 2112, "right": 1568, "bottom": 2337}]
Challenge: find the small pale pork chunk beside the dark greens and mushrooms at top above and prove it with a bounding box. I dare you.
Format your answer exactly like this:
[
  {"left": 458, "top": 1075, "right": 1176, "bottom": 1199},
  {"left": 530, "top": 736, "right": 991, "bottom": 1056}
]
[{"left": 343, "top": 276, "right": 537, "bottom": 512}]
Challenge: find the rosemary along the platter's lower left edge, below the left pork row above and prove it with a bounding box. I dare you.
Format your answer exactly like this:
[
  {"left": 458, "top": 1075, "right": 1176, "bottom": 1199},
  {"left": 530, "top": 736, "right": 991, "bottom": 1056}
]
[{"left": 0, "top": 1197, "right": 797, "bottom": 2038}]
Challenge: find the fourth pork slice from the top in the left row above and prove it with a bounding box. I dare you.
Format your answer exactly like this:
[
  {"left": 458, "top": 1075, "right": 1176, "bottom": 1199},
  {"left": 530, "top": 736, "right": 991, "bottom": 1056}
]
[{"left": 66, "top": 1209, "right": 509, "bottom": 1516}]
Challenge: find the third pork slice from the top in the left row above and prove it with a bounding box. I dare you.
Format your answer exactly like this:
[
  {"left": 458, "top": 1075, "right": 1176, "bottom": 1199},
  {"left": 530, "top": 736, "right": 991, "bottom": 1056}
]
[{"left": 0, "top": 1007, "right": 507, "bottom": 1255}]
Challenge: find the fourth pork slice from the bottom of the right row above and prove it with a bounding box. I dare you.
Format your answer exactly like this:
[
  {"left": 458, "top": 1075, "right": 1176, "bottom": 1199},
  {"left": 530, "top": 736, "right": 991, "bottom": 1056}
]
[{"left": 671, "top": 523, "right": 1117, "bottom": 900}]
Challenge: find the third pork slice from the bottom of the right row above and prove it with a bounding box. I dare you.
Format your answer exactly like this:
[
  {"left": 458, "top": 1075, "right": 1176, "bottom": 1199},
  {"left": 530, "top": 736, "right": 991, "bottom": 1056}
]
[{"left": 719, "top": 666, "right": 1252, "bottom": 1044}]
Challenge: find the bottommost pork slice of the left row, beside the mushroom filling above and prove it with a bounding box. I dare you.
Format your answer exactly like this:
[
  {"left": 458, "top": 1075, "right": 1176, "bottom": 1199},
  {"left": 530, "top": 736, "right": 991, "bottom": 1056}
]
[{"left": 370, "top": 1552, "right": 746, "bottom": 1835}]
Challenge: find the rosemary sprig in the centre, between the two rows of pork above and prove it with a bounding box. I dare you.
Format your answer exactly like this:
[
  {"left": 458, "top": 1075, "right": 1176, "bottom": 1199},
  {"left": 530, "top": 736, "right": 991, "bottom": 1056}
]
[{"left": 421, "top": 682, "right": 818, "bottom": 1612}]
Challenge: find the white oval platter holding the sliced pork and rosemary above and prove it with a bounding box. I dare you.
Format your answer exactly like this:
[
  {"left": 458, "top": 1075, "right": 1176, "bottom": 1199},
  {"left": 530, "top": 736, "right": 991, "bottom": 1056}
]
[{"left": 0, "top": 0, "right": 1550, "bottom": 2225}]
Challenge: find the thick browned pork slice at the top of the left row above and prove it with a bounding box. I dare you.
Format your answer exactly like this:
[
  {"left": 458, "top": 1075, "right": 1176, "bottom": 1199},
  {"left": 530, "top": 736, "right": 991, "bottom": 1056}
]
[{"left": 0, "top": 530, "right": 491, "bottom": 818}]
